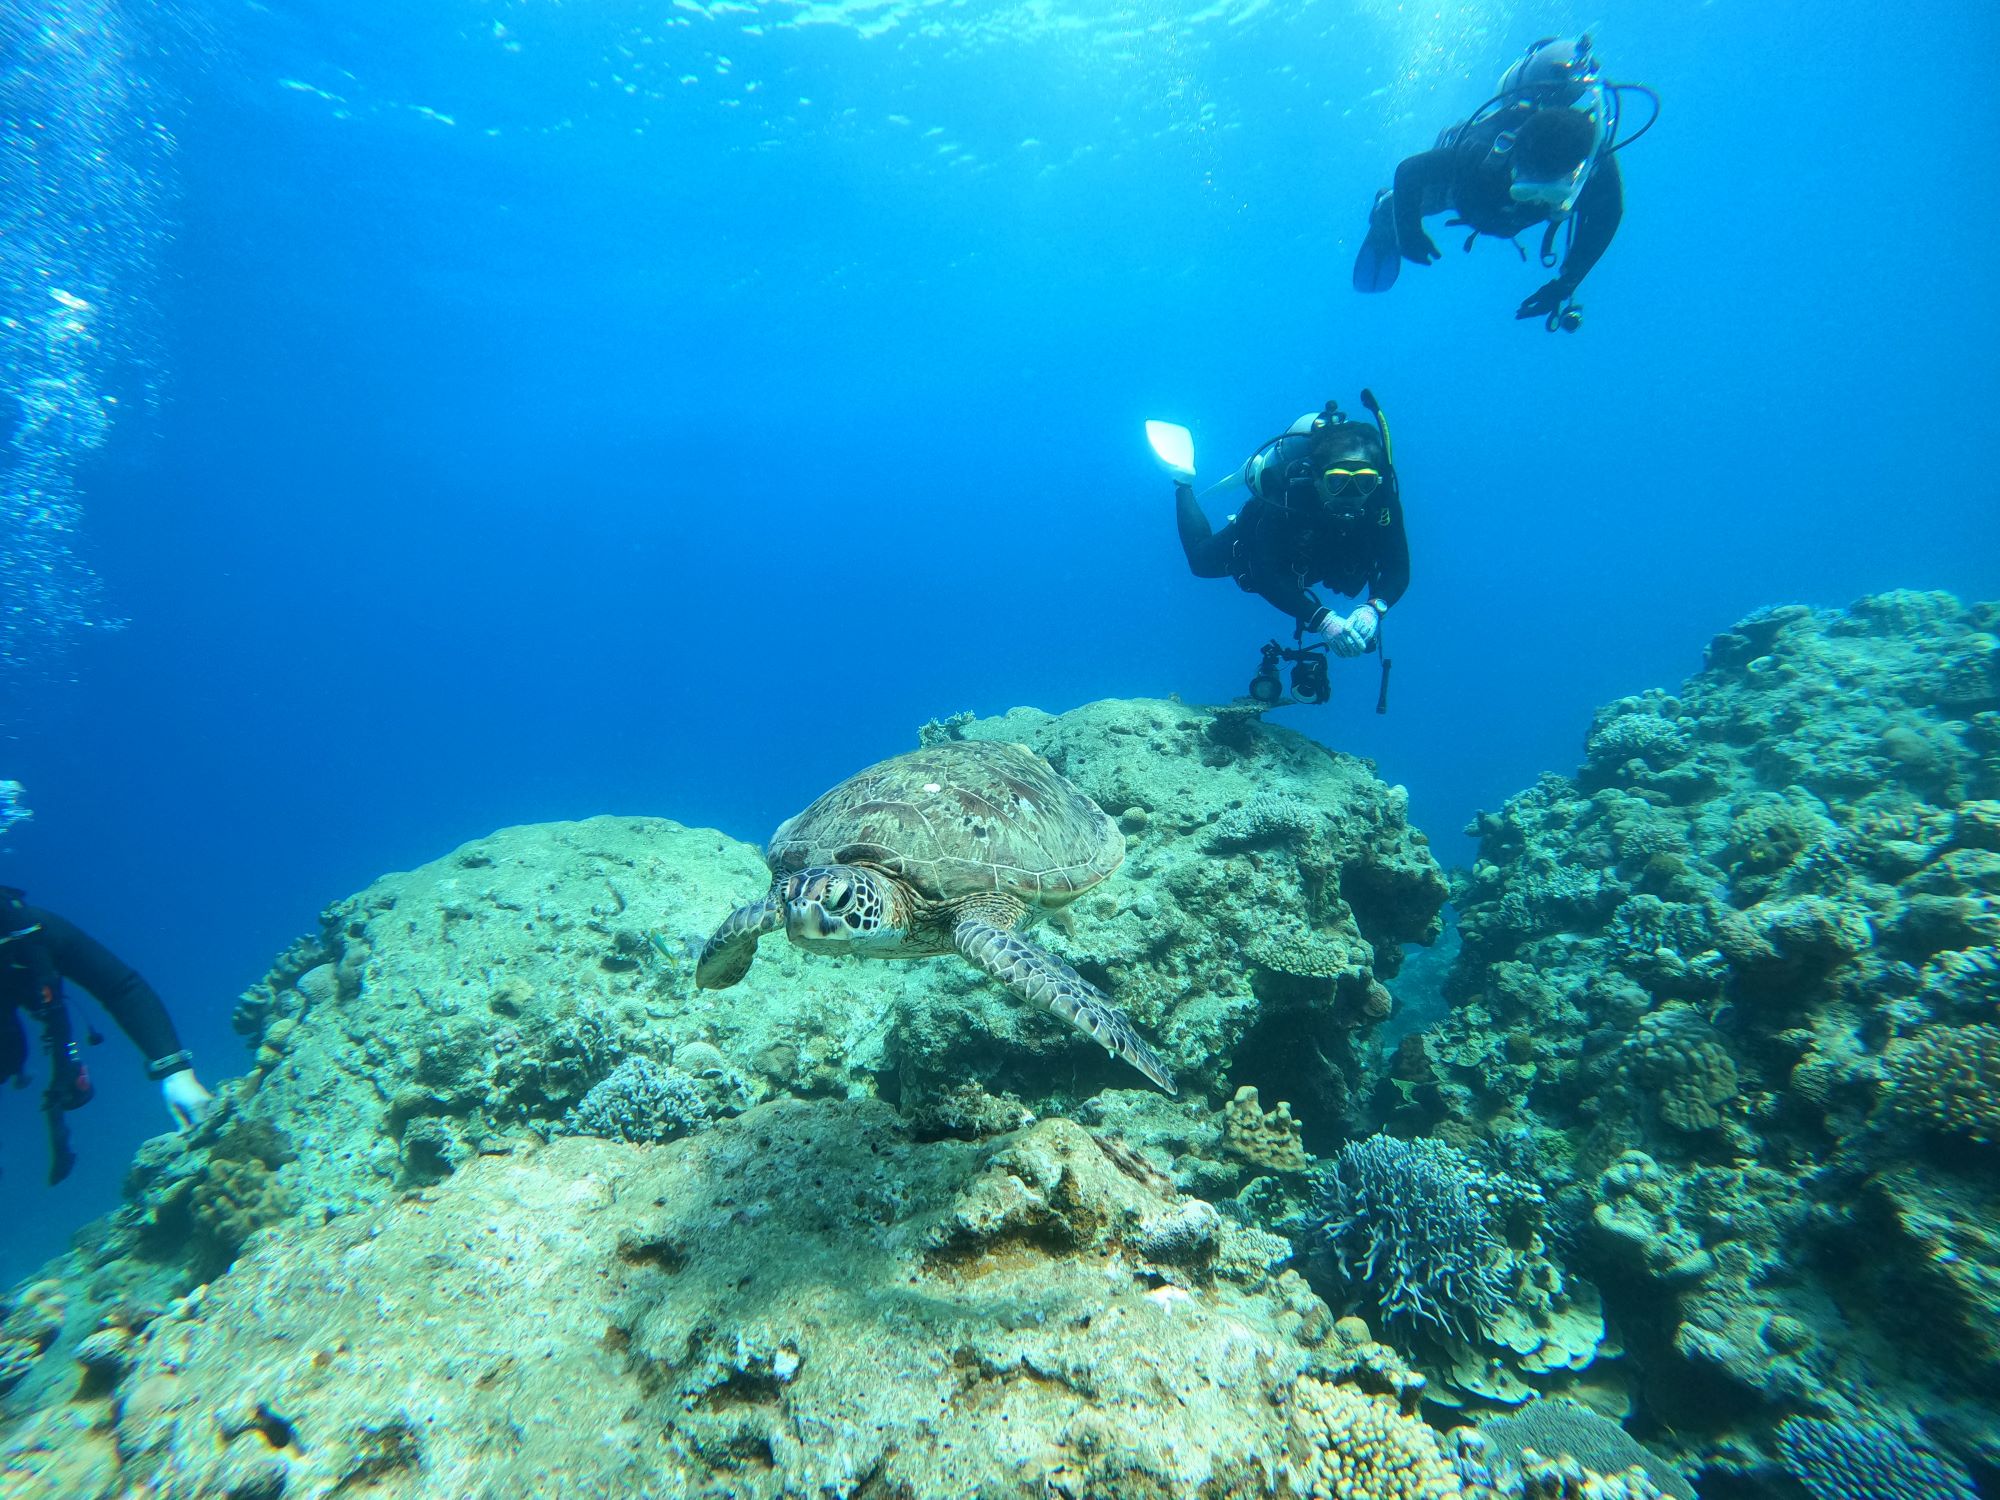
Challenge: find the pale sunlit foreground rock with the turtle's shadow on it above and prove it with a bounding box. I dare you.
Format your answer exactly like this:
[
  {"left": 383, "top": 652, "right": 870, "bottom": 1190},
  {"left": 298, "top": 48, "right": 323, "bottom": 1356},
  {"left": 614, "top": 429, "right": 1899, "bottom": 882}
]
[{"left": 0, "top": 1102, "right": 1360, "bottom": 1500}]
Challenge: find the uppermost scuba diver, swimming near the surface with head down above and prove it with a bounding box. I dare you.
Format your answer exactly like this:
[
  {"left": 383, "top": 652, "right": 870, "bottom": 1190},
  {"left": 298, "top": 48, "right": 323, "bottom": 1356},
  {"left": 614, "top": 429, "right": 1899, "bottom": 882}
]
[{"left": 1354, "top": 36, "right": 1660, "bottom": 332}]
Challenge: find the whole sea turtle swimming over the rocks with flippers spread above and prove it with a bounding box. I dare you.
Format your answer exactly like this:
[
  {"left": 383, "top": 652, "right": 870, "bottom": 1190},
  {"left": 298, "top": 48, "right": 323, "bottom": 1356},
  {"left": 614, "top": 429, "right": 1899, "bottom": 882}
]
[{"left": 694, "top": 740, "right": 1174, "bottom": 1094}]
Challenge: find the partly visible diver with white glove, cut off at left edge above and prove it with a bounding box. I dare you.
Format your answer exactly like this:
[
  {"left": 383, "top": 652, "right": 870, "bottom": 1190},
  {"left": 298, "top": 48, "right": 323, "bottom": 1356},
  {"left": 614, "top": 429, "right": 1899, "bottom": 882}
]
[{"left": 0, "top": 886, "right": 210, "bottom": 1184}]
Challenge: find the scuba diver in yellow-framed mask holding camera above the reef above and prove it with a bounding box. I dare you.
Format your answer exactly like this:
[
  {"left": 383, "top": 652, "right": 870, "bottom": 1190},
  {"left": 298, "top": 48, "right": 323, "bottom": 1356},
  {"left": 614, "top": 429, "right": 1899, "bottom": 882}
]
[{"left": 1146, "top": 390, "right": 1410, "bottom": 714}]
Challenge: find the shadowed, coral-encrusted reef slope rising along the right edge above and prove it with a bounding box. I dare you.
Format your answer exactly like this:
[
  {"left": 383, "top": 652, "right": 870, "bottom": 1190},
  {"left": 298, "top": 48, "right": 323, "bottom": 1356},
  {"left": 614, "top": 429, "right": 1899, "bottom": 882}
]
[{"left": 1380, "top": 592, "right": 2000, "bottom": 1494}]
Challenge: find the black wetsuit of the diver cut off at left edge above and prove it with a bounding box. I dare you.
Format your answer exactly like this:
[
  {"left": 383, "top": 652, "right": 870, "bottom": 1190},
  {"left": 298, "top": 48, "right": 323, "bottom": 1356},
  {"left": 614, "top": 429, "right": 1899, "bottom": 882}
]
[{"left": 0, "top": 890, "right": 188, "bottom": 1082}]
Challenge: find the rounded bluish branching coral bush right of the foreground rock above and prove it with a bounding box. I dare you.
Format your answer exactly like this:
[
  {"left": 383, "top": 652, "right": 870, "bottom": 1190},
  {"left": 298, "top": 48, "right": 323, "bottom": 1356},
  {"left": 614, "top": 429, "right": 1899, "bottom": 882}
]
[{"left": 1308, "top": 1136, "right": 1508, "bottom": 1342}]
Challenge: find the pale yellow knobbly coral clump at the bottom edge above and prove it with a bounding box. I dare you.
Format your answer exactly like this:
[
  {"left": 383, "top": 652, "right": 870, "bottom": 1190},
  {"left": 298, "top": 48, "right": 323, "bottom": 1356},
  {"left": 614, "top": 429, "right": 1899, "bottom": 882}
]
[{"left": 1290, "top": 1376, "right": 1462, "bottom": 1500}]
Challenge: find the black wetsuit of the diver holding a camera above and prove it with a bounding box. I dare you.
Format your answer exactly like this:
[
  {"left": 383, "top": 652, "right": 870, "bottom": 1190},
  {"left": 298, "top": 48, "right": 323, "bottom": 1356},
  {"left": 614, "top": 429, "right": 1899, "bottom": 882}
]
[{"left": 1174, "top": 436, "right": 1410, "bottom": 630}]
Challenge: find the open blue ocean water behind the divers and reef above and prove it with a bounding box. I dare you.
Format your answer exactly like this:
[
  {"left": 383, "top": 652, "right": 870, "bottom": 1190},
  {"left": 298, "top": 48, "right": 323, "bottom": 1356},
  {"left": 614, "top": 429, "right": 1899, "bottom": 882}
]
[{"left": 0, "top": 0, "right": 2000, "bottom": 1278}]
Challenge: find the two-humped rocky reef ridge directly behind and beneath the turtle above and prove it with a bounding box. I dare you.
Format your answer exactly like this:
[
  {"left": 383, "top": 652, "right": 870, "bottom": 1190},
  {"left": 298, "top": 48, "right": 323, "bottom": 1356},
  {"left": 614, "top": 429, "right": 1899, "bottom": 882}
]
[{"left": 0, "top": 702, "right": 1446, "bottom": 1456}]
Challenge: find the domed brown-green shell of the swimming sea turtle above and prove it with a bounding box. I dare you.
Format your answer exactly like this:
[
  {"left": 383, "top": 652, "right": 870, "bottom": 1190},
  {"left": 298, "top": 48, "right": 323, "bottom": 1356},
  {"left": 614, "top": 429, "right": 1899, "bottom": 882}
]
[{"left": 764, "top": 740, "right": 1124, "bottom": 908}]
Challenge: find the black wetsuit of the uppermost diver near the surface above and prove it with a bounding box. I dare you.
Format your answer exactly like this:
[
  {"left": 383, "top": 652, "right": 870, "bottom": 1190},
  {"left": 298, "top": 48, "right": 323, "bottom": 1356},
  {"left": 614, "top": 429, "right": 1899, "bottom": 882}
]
[{"left": 1394, "top": 102, "right": 1624, "bottom": 316}]
